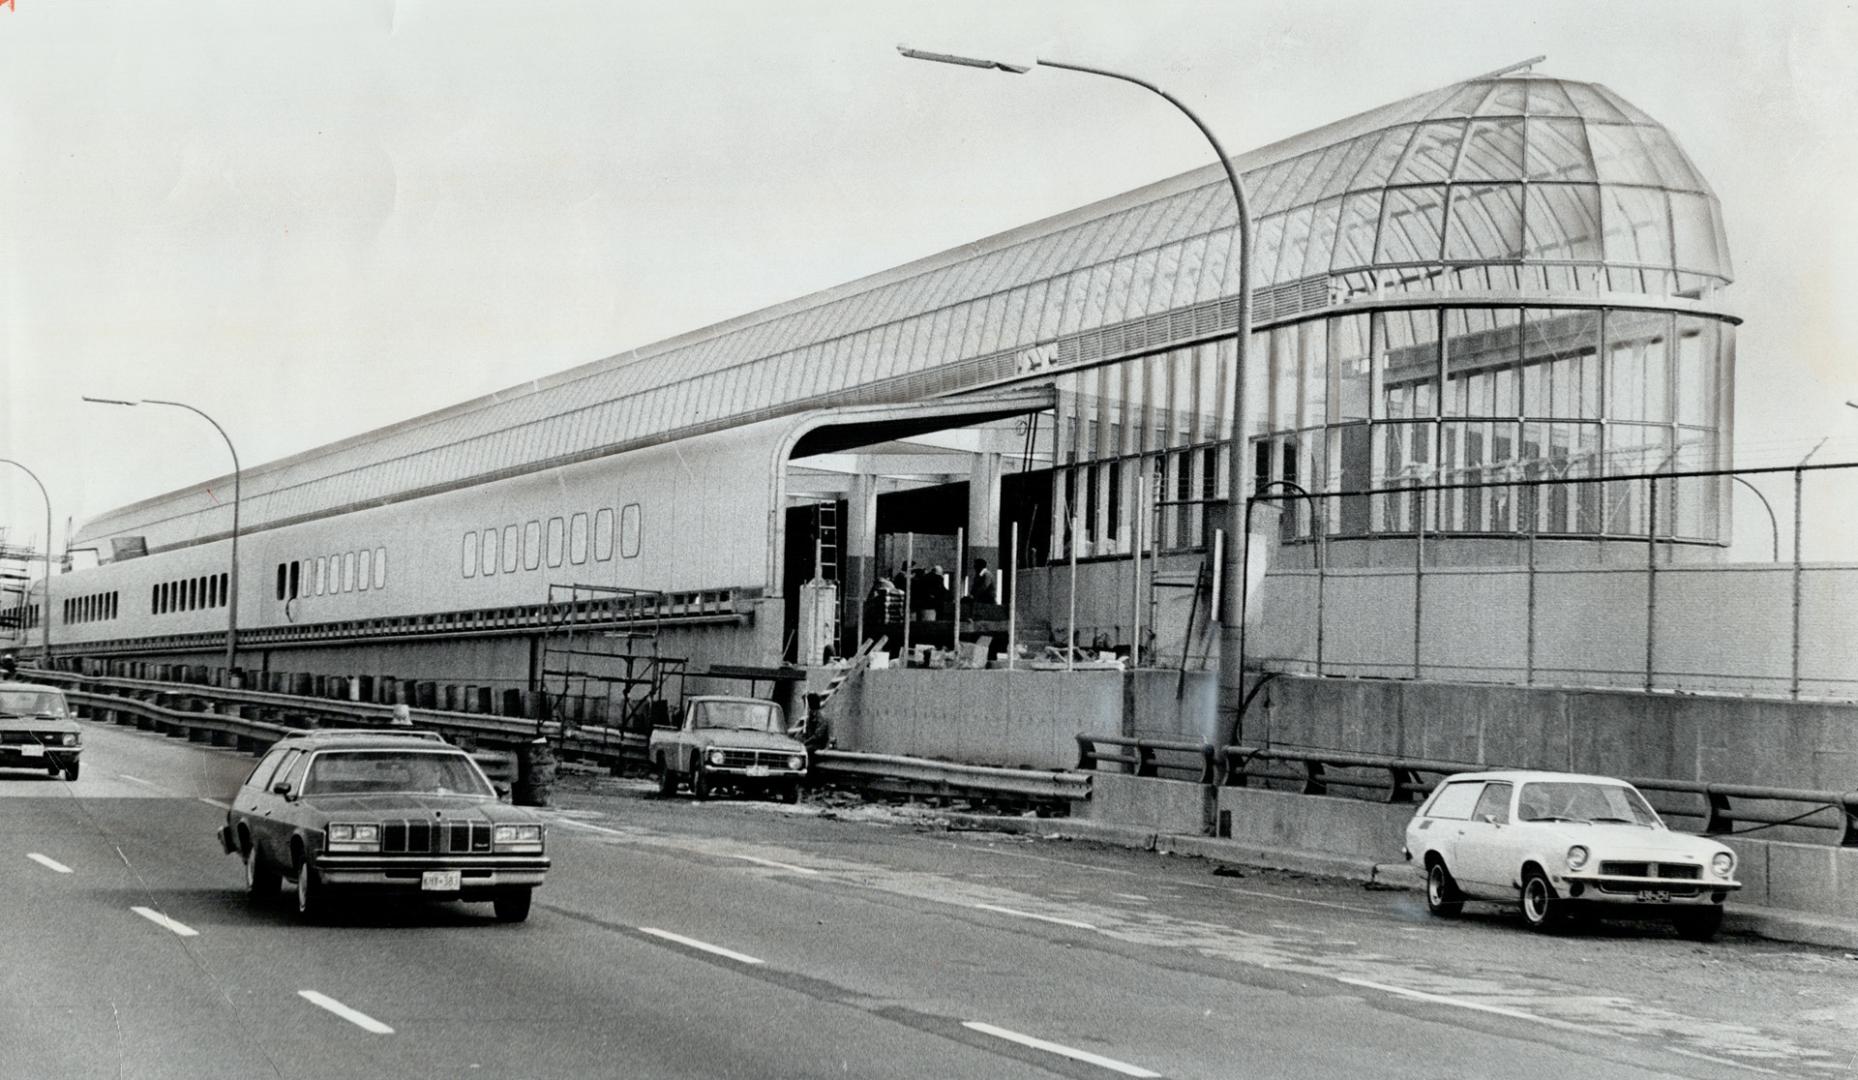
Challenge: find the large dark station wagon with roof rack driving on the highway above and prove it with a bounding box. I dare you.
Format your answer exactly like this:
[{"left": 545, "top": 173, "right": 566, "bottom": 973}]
[{"left": 219, "top": 731, "right": 548, "bottom": 922}]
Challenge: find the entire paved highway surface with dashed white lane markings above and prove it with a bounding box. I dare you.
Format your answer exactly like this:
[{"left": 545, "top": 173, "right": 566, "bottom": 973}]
[{"left": 0, "top": 723, "right": 1858, "bottom": 1080}]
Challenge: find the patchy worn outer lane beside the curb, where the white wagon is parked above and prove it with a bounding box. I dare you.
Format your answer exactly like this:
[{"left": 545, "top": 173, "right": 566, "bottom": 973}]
[{"left": 542, "top": 784, "right": 1858, "bottom": 1071}]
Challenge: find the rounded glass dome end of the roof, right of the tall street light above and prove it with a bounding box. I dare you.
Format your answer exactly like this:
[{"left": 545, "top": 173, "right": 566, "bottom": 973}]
[{"left": 1247, "top": 74, "right": 1730, "bottom": 294}]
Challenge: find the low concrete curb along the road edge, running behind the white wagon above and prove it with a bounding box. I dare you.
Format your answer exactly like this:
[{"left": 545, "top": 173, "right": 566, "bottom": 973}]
[{"left": 948, "top": 814, "right": 1858, "bottom": 952}]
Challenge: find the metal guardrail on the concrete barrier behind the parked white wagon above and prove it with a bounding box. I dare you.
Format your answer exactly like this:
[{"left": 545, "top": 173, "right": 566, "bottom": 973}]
[{"left": 1078, "top": 734, "right": 1858, "bottom": 848}]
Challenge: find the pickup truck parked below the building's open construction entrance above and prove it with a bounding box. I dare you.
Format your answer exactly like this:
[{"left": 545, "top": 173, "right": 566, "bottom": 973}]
[{"left": 647, "top": 695, "right": 806, "bottom": 803}]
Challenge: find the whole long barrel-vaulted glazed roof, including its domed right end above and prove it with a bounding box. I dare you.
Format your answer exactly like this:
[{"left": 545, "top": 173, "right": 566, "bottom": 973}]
[{"left": 78, "top": 74, "right": 1730, "bottom": 548}]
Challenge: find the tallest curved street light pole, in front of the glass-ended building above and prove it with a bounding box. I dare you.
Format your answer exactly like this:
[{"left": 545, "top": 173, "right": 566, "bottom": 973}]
[{"left": 897, "top": 45, "right": 1252, "bottom": 742}]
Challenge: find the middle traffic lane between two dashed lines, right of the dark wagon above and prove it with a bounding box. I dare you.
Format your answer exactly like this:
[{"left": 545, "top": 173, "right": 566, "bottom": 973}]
[{"left": 546, "top": 822, "right": 1704, "bottom": 1078}]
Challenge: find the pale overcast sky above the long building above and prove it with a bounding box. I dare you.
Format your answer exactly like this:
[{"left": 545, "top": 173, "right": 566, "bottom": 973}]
[{"left": 0, "top": 0, "right": 1858, "bottom": 560}]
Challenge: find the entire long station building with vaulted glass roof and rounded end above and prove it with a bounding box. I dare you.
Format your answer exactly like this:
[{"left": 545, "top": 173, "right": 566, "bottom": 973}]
[{"left": 20, "top": 71, "right": 1737, "bottom": 705}]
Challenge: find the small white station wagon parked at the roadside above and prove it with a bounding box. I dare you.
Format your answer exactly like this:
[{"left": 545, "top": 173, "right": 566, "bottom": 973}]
[{"left": 1407, "top": 771, "right": 1741, "bottom": 941}]
